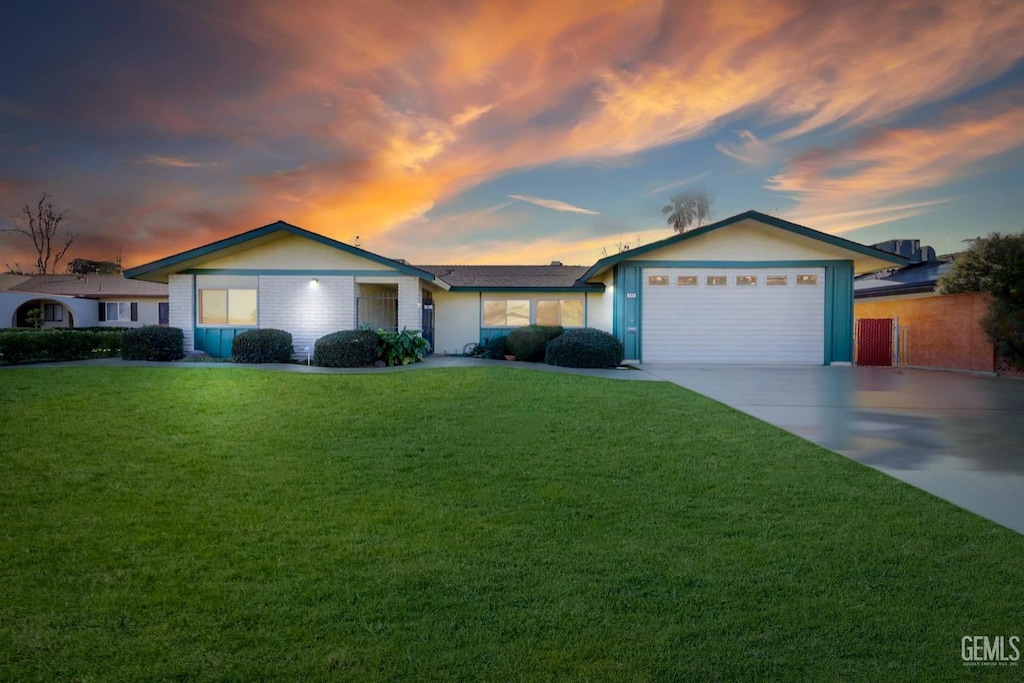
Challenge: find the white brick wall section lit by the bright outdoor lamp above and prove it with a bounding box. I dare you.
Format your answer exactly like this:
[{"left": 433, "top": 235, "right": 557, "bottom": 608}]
[{"left": 258, "top": 275, "right": 358, "bottom": 355}]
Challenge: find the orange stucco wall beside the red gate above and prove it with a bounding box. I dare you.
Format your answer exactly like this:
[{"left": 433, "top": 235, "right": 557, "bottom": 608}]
[{"left": 854, "top": 294, "right": 995, "bottom": 372}]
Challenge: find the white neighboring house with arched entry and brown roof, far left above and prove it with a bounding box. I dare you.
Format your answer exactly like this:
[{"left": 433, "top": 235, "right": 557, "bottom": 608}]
[{"left": 0, "top": 274, "right": 169, "bottom": 328}]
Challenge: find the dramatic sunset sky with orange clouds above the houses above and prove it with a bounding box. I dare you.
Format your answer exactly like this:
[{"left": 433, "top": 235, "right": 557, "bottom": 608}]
[{"left": 0, "top": 0, "right": 1024, "bottom": 267}]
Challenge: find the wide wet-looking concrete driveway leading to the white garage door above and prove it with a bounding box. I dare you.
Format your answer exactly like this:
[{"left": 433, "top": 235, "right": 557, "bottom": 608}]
[{"left": 642, "top": 364, "right": 1024, "bottom": 533}]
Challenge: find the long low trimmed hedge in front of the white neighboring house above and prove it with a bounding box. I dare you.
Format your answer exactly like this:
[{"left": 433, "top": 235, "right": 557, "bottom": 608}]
[{"left": 0, "top": 330, "right": 121, "bottom": 365}]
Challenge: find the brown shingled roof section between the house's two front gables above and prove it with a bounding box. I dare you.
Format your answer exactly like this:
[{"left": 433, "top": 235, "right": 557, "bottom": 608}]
[{"left": 417, "top": 265, "right": 604, "bottom": 291}]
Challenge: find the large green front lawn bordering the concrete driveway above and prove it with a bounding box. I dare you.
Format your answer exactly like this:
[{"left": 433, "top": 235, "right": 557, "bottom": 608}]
[{"left": 0, "top": 368, "right": 1024, "bottom": 681}]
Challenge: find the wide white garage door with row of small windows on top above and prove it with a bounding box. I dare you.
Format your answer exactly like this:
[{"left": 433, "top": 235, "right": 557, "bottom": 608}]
[{"left": 641, "top": 268, "right": 825, "bottom": 365}]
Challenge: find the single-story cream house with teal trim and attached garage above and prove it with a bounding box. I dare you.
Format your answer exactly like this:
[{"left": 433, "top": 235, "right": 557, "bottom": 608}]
[{"left": 125, "top": 211, "right": 906, "bottom": 365}]
